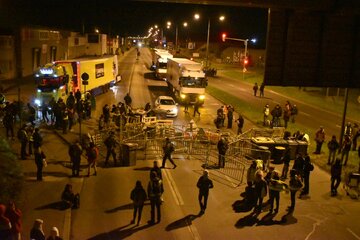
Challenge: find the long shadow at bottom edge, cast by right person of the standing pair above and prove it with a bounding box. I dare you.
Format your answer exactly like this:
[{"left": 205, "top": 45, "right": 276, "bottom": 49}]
[{"left": 89, "top": 224, "right": 151, "bottom": 240}]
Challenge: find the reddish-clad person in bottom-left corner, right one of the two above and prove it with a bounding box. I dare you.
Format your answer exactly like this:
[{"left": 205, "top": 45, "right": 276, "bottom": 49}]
[{"left": 4, "top": 201, "right": 22, "bottom": 240}]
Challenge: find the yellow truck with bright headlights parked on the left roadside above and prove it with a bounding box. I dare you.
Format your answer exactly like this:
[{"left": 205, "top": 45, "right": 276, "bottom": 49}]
[{"left": 35, "top": 55, "right": 121, "bottom": 107}]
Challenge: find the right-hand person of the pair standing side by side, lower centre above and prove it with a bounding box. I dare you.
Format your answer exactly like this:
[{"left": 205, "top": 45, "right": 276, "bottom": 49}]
[{"left": 147, "top": 172, "right": 164, "bottom": 225}]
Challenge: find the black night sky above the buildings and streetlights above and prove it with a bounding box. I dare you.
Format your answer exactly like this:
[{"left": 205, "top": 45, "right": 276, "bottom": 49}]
[{"left": 0, "top": 0, "right": 267, "bottom": 45}]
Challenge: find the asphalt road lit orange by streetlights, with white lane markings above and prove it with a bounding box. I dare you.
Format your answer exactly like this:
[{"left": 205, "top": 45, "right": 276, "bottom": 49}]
[{"left": 13, "top": 49, "right": 360, "bottom": 240}]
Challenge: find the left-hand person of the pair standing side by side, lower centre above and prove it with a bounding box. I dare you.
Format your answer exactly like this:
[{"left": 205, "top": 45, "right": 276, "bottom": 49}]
[{"left": 130, "top": 180, "right": 147, "bottom": 226}]
